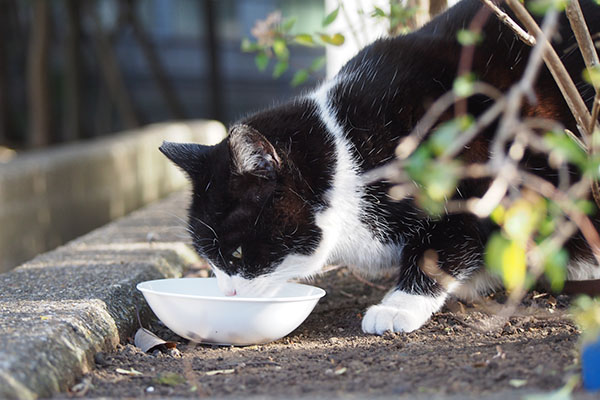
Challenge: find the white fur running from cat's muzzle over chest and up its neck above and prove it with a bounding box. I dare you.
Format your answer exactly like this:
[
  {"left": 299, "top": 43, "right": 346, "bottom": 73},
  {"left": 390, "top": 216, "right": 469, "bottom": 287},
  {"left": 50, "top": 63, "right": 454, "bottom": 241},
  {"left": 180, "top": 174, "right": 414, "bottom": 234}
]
[{"left": 215, "top": 80, "right": 402, "bottom": 296}]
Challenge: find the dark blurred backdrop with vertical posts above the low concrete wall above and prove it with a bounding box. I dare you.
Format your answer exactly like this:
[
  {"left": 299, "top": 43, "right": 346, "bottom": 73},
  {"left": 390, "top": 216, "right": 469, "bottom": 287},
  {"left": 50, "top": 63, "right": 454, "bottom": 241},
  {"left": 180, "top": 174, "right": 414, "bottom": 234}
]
[{"left": 0, "top": 0, "right": 325, "bottom": 152}]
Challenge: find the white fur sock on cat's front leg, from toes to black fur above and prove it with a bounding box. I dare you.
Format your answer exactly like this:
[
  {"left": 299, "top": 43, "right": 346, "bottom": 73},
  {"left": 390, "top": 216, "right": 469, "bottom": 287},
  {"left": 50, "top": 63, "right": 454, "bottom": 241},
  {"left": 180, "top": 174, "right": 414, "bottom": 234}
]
[{"left": 362, "top": 290, "right": 447, "bottom": 335}]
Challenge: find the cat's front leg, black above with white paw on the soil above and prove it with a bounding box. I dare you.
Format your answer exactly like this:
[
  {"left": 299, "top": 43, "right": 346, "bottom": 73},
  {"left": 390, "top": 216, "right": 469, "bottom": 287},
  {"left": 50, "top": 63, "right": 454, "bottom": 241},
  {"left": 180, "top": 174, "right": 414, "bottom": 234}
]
[{"left": 362, "top": 215, "right": 486, "bottom": 335}]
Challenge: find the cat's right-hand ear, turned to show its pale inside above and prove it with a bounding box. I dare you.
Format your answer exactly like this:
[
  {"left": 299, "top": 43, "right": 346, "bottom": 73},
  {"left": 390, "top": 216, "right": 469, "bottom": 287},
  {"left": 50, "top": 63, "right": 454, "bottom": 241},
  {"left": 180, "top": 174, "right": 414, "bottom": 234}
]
[{"left": 229, "top": 125, "right": 281, "bottom": 178}]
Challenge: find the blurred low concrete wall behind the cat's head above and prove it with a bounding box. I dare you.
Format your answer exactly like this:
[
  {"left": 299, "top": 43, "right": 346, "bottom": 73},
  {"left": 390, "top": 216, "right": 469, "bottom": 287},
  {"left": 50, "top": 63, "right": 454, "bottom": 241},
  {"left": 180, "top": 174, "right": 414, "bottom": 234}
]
[{"left": 0, "top": 121, "right": 226, "bottom": 272}]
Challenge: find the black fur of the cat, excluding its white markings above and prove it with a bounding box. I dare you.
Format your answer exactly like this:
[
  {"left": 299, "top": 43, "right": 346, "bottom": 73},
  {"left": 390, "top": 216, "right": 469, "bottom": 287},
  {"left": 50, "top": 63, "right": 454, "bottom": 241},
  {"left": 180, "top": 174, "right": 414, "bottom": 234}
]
[{"left": 161, "top": 0, "right": 600, "bottom": 324}]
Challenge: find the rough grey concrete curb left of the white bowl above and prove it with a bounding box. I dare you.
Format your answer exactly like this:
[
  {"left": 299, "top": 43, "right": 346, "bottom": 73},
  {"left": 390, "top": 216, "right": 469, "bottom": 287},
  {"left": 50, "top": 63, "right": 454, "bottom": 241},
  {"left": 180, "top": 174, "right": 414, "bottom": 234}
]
[{"left": 0, "top": 193, "right": 197, "bottom": 399}]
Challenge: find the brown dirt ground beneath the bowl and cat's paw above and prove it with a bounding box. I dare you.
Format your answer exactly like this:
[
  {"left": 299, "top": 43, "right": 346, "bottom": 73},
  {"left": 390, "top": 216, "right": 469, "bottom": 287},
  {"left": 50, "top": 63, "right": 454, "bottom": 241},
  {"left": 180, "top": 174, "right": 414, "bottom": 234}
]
[{"left": 61, "top": 268, "right": 593, "bottom": 398}]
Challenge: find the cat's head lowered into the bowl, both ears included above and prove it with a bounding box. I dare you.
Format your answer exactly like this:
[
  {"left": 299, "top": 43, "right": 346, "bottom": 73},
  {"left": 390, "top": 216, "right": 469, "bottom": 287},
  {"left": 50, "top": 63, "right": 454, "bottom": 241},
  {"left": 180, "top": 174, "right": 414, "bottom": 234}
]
[{"left": 160, "top": 124, "right": 320, "bottom": 296}]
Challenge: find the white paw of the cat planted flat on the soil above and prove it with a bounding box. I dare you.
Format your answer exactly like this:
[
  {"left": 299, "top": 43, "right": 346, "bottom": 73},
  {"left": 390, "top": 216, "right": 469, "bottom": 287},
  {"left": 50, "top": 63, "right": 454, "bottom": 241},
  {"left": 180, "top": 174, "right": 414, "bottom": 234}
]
[{"left": 362, "top": 304, "right": 429, "bottom": 335}]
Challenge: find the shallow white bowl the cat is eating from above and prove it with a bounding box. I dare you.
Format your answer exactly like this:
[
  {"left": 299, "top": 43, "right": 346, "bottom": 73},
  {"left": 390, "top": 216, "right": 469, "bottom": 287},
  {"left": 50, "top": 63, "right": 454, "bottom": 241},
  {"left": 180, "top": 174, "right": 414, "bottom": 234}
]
[{"left": 137, "top": 278, "right": 325, "bottom": 346}]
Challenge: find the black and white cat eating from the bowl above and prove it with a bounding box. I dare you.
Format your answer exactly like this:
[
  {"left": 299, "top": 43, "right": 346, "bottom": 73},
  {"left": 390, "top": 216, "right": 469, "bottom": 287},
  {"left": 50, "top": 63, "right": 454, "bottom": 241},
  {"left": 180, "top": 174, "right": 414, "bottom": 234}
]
[{"left": 160, "top": 0, "right": 600, "bottom": 334}]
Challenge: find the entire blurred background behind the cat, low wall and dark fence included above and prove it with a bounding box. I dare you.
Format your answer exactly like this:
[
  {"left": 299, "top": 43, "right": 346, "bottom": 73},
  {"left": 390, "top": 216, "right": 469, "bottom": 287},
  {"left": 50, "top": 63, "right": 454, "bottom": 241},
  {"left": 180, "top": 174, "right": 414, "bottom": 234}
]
[{"left": 0, "top": 0, "right": 442, "bottom": 273}]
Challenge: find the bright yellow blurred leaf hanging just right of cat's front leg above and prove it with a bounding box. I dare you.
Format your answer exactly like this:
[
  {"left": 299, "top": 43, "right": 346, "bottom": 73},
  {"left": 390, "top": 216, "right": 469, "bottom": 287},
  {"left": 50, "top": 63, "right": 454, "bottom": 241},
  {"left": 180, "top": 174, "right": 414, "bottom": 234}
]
[{"left": 485, "top": 232, "right": 527, "bottom": 290}]
